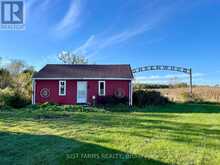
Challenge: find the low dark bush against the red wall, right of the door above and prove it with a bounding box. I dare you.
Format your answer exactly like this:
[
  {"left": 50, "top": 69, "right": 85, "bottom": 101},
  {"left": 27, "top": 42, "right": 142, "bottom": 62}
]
[{"left": 98, "top": 96, "right": 128, "bottom": 105}]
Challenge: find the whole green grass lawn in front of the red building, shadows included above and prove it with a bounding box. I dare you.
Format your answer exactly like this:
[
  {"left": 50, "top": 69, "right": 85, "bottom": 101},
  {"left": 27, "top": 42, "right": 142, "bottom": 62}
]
[{"left": 0, "top": 104, "right": 220, "bottom": 165}]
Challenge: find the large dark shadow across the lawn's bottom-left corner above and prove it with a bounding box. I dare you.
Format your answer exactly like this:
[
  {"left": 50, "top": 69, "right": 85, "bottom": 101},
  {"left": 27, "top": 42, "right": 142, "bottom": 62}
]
[{"left": 0, "top": 132, "right": 169, "bottom": 165}]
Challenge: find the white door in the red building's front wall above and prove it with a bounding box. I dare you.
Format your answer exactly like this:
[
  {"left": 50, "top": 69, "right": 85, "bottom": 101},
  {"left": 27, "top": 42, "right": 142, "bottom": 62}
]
[{"left": 77, "top": 81, "right": 87, "bottom": 103}]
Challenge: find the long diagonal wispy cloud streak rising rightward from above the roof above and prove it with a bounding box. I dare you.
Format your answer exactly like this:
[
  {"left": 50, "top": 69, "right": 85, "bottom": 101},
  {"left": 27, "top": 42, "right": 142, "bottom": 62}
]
[{"left": 74, "top": 0, "right": 179, "bottom": 57}]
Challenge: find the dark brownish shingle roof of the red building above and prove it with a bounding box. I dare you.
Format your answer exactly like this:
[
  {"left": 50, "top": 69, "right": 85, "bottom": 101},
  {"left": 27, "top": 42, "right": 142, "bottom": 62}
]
[{"left": 33, "top": 64, "right": 133, "bottom": 79}]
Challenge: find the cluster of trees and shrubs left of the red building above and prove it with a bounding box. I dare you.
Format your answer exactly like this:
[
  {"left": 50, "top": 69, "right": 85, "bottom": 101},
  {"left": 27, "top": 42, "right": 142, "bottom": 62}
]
[{"left": 0, "top": 59, "right": 35, "bottom": 106}]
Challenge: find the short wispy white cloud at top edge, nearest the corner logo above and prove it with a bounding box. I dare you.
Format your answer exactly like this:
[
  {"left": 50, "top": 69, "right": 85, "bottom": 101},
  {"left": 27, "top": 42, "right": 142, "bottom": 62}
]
[{"left": 55, "top": 0, "right": 82, "bottom": 35}]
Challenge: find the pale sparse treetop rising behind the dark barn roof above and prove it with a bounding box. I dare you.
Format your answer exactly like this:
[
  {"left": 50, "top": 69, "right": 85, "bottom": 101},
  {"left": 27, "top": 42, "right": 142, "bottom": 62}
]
[{"left": 58, "top": 51, "right": 88, "bottom": 64}]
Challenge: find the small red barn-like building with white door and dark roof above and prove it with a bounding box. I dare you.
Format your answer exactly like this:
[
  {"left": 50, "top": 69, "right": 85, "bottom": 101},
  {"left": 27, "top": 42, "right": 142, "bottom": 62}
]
[{"left": 32, "top": 64, "right": 133, "bottom": 105}]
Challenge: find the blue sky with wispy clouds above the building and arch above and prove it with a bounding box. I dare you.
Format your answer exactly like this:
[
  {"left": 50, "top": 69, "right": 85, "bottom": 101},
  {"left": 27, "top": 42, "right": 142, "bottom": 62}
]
[{"left": 0, "top": 0, "right": 220, "bottom": 85}]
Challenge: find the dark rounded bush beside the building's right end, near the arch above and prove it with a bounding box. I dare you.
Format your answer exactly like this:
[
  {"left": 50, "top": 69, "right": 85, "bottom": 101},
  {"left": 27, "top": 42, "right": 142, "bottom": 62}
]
[{"left": 133, "top": 91, "right": 169, "bottom": 107}]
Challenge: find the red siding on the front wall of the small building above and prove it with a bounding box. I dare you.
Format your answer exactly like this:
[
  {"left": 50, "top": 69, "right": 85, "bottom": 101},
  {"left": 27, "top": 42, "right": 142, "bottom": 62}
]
[{"left": 35, "top": 80, "right": 130, "bottom": 104}]
